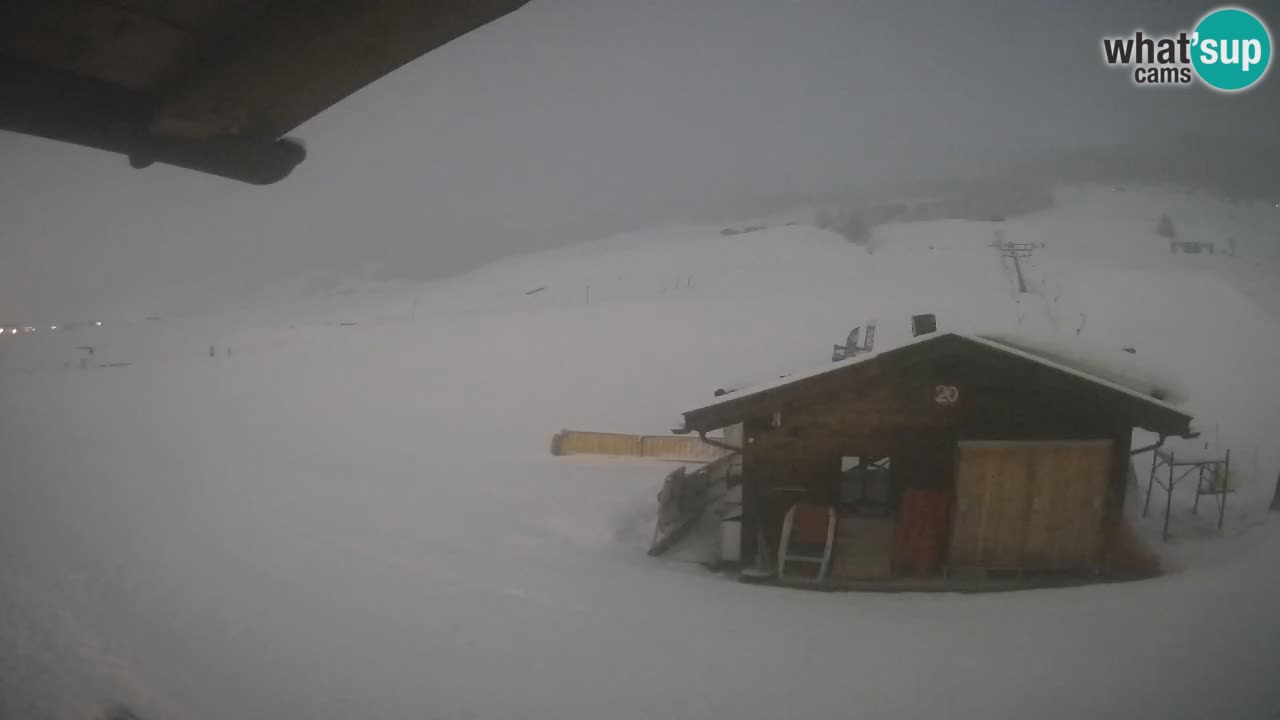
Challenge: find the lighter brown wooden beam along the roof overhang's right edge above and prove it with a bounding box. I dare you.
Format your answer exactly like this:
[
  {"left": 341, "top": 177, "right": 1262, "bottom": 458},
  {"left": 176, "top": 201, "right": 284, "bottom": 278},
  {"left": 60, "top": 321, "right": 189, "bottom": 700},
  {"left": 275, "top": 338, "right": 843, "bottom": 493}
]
[{"left": 152, "top": 0, "right": 527, "bottom": 137}]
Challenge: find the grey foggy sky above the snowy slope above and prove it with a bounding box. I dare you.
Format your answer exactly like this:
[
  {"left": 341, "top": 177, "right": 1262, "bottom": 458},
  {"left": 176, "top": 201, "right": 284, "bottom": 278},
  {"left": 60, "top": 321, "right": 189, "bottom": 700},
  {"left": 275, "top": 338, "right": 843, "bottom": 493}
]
[{"left": 0, "top": 0, "right": 1280, "bottom": 322}]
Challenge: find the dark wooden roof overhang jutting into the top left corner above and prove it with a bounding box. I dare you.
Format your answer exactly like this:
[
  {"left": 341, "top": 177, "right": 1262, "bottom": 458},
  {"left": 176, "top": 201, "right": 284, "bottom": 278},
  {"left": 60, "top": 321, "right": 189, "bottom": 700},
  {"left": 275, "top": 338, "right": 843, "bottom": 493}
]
[{"left": 0, "top": 0, "right": 527, "bottom": 184}]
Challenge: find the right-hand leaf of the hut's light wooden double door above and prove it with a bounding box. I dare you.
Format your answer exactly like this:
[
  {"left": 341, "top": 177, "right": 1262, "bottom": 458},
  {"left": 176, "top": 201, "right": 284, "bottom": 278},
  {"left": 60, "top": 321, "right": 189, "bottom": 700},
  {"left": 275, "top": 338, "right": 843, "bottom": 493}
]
[{"left": 1024, "top": 441, "right": 1112, "bottom": 569}]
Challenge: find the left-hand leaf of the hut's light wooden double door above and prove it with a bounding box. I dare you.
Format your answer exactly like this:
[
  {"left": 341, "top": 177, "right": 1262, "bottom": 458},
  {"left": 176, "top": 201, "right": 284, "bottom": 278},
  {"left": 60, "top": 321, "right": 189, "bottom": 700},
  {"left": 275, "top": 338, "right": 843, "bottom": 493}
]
[{"left": 948, "top": 442, "right": 1033, "bottom": 568}]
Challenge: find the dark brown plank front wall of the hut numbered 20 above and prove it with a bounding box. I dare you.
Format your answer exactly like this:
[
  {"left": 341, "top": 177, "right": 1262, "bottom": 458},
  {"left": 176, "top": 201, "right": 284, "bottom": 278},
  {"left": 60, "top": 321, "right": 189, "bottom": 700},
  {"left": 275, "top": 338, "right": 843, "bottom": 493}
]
[{"left": 742, "top": 357, "right": 1132, "bottom": 571}]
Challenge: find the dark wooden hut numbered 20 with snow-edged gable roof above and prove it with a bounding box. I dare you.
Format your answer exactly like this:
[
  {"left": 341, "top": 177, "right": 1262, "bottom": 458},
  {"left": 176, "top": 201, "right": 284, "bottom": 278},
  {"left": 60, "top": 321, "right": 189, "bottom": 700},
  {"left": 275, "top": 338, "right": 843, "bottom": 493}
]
[{"left": 675, "top": 334, "right": 1190, "bottom": 584}]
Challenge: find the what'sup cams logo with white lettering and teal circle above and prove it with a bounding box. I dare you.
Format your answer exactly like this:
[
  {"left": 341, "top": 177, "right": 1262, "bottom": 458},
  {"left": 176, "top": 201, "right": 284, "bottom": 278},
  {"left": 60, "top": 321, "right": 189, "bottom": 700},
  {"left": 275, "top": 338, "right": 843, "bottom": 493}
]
[{"left": 1102, "top": 8, "right": 1271, "bottom": 92}]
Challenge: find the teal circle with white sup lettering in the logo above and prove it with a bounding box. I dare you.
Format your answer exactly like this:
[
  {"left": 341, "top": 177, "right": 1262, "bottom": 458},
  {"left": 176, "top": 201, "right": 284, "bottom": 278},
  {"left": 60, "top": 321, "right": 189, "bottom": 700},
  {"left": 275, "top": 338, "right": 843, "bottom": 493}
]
[{"left": 1192, "top": 8, "right": 1271, "bottom": 92}]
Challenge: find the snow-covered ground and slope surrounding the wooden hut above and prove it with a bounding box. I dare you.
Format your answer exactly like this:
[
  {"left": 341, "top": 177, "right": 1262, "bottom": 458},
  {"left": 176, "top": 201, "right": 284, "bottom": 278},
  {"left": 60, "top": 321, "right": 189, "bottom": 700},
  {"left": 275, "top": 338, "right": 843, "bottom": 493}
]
[{"left": 0, "top": 187, "right": 1280, "bottom": 719}]
